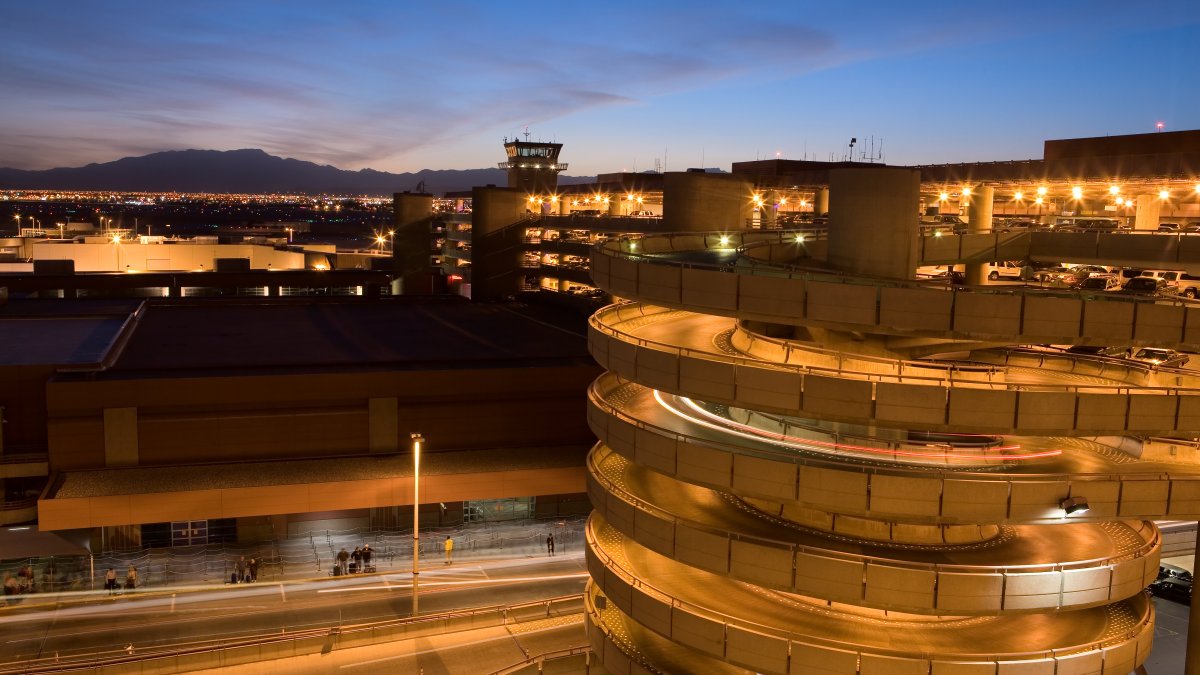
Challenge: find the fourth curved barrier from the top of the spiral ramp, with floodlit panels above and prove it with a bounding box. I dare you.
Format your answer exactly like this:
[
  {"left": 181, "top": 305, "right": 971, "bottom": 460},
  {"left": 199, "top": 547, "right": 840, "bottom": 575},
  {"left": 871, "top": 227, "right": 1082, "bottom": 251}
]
[{"left": 588, "top": 461, "right": 1159, "bottom": 614}]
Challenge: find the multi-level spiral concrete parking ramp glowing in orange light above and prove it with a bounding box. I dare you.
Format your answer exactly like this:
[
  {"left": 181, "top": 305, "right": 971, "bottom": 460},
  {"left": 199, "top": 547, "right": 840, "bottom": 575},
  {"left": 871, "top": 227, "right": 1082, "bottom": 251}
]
[{"left": 587, "top": 233, "right": 1200, "bottom": 675}]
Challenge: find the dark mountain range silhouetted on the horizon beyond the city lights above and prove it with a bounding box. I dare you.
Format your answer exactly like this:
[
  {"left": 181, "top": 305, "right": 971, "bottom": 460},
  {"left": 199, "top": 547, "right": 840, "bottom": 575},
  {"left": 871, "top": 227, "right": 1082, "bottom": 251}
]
[{"left": 0, "top": 149, "right": 595, "bottom": 195}]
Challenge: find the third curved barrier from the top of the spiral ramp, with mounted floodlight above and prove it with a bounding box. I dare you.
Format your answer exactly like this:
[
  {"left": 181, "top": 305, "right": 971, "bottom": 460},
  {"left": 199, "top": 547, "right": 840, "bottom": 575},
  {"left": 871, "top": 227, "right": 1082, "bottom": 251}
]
[{"left": 589, "top": 386, "right": 1200, "bottom": 525}]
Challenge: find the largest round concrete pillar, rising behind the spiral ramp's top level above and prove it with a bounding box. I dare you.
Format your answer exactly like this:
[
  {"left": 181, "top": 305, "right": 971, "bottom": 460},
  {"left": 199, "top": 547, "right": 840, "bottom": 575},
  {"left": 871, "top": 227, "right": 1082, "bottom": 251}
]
[{"left": 828, "top": 167, "right": 920, "bottom": 279}]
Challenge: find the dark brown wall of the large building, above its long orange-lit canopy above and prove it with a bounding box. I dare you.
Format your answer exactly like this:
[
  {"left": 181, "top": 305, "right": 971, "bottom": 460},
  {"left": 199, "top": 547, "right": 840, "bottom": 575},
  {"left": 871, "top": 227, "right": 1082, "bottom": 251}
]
[{"left": 47, "top": 364, "right": 599, "bottom": 471}]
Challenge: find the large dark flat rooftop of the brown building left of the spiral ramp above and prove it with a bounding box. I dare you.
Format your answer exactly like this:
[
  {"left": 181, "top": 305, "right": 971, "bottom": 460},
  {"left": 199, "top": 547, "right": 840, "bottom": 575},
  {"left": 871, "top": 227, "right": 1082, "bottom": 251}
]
[{"left": 110, "top": 300, "right": 590, "bottom": 375}]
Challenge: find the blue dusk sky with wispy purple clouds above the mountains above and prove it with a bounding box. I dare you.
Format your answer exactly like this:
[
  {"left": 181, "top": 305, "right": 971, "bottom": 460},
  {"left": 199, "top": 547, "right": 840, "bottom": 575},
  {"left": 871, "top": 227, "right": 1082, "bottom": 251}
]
[{"left": 0, "top": 0, "right": 1200, "bottom": 175}]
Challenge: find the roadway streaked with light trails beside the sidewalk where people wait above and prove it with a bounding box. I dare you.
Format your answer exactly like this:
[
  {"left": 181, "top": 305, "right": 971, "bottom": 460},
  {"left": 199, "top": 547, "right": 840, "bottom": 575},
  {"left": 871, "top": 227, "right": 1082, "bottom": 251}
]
[{"left": 0, "top": 551, "right": 587, "bottom": 667}]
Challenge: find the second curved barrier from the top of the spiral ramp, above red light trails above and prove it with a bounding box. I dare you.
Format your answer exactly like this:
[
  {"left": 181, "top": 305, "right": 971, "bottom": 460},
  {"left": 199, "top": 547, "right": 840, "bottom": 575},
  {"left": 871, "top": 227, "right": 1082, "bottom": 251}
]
[{"left": 588, "top": 307, "right": 1200, "bottom": 436}]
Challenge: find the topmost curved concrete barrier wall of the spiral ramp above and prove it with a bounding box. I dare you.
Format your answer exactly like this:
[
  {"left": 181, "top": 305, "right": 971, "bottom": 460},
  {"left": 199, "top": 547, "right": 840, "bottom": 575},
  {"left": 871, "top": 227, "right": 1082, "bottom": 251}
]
[{"left": 593, "top": 243, "right": 1200, "bottom": 351}]
